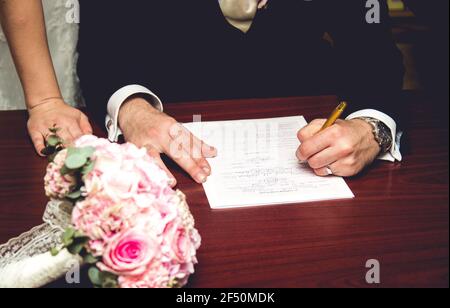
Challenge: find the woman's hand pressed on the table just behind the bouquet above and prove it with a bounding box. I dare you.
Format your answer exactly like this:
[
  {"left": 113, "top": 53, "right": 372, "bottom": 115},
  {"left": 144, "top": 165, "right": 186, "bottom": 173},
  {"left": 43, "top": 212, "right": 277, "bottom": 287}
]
[{"left": 27, "top": 99, "right": 92, "bottom": 156}]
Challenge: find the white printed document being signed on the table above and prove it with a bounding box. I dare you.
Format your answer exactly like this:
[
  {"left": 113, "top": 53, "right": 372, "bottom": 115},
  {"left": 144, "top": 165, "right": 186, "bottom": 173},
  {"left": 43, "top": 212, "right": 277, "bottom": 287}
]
[{"left": 185, "top": 116, "right": 354, "bottom": 209}]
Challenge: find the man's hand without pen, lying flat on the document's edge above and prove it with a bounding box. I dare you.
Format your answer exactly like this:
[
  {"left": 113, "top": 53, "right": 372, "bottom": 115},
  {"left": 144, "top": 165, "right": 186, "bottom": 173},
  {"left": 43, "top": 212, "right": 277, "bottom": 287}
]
[{"left": 119, "top": 98, "right": 217, "bottom": 186}]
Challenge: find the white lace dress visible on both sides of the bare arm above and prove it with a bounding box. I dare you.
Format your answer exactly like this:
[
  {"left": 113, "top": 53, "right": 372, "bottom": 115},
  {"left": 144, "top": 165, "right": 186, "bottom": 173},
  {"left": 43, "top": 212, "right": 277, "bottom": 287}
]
[{"left": 0, "top": 0, "right": 82, "bottom": 110}]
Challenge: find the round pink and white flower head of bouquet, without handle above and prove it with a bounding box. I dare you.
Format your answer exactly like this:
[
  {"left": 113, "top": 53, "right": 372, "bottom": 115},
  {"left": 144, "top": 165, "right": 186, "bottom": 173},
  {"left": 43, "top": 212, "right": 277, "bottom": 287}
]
[{"left": 0, "top": 134, "right": 201, "bottom": 288}]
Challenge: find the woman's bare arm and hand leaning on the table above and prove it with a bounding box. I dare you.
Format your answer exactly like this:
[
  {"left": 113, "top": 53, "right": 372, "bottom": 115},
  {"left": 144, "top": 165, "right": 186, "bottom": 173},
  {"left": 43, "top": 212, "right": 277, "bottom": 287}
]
[{"left": 0, "top": 0, "right": 92, "bottom": 153}]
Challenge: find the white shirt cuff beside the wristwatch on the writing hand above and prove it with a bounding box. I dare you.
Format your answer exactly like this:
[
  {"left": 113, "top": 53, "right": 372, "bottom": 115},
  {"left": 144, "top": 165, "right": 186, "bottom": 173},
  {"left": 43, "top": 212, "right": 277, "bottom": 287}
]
[{"left": 347, "top": 109, "right": 403, "bottom": 162}]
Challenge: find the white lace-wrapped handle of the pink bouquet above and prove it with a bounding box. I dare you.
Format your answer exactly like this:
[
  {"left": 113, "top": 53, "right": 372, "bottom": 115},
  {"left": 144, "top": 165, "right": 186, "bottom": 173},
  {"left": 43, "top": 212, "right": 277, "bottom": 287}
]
[{"left": 0, "top": 201, "right": 81, "bottom": 288}]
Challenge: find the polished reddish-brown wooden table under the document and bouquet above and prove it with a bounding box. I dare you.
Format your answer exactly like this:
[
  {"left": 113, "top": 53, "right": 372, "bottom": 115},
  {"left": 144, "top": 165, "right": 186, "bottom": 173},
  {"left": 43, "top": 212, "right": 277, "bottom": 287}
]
[{"left": 0, "top": 97, "right": 449, "bottom": 287}]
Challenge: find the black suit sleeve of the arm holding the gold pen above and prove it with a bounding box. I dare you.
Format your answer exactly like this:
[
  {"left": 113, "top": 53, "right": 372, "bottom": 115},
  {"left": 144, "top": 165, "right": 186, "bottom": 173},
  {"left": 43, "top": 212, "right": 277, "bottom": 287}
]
[{"left": 323, "top": 0, "right": 404, "bottom": 125}]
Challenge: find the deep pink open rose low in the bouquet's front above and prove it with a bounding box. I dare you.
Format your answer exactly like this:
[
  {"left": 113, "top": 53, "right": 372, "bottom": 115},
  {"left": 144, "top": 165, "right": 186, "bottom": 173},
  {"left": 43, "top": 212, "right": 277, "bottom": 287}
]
[{"left": 98, "top": 230, "right": 159, "bottom": 276}]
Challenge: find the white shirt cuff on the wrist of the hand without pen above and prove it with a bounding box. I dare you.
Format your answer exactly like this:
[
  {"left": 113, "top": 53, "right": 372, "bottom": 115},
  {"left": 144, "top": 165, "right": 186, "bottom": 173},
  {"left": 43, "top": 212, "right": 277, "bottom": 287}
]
[{"left": 106, "top": 85, "right": 163, "bottom": 142}]
